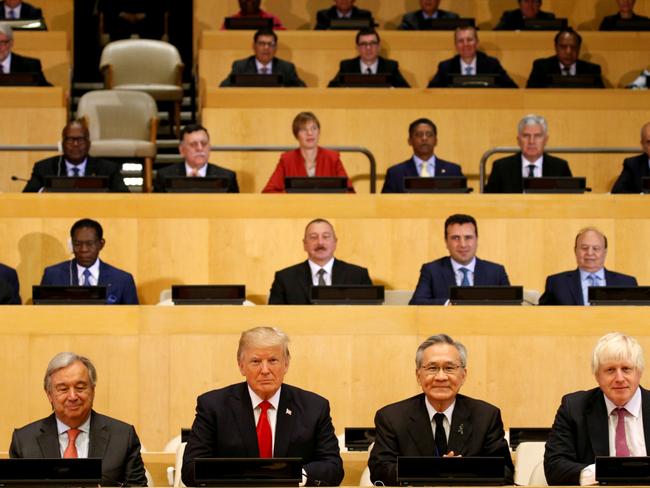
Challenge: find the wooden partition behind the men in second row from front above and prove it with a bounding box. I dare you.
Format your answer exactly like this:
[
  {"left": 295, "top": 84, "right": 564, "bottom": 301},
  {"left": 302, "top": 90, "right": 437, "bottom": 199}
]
[{"left": 0, "top": 194, "right": 650, "bottom": 304}]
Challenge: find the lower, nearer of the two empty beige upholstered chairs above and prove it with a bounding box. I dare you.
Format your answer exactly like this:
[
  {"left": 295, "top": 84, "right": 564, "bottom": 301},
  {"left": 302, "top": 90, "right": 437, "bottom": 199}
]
[{"left": 77, "top": 90, "right": 158, "bottom": 192}]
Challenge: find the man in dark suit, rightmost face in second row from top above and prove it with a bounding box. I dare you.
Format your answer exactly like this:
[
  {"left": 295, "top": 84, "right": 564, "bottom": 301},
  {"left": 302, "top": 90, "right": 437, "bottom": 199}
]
[{"left": 526, "top": 27, "right": 605, "bottom": 88}]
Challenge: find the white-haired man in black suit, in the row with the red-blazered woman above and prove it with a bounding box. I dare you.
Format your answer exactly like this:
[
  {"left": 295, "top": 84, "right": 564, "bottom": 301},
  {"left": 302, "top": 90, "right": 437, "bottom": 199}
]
[{"left": 485, "top": 114, "right": 571, "bottom": 193}]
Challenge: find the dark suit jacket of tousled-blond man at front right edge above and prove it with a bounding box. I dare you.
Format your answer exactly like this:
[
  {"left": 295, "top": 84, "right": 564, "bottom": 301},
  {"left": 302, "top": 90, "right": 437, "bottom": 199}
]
[{"left": 544, "top": 387, "right": 650, "bottom": 485}]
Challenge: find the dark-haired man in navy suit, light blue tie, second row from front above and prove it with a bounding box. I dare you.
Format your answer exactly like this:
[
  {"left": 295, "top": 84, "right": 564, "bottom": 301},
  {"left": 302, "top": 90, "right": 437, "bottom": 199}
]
[{"left": 409, "top": 214, "right": 510, "bottom": 305}]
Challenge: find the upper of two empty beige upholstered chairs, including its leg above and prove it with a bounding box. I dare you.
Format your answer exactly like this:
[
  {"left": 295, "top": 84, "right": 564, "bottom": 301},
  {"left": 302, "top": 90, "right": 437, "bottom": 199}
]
[{"left": 99, "top": 39, "right": 183, "bottom": 137}]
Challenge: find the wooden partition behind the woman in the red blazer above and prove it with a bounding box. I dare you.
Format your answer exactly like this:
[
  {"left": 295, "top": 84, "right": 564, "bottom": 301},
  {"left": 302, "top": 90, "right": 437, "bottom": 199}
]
[{"left": 202, "top": 88, "right": 650, "bottom": 193}]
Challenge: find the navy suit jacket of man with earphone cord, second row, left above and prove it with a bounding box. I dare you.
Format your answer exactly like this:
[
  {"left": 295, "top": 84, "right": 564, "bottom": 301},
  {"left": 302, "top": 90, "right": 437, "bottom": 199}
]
[{"left": 41, "top": 259, "right": 138, "bottom": 305}]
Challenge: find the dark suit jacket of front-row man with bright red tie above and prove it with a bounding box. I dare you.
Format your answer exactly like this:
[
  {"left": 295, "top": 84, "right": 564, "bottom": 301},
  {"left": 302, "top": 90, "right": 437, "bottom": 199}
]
[{"left": 182, "top": 382, "right": 343, "bottom": 486}]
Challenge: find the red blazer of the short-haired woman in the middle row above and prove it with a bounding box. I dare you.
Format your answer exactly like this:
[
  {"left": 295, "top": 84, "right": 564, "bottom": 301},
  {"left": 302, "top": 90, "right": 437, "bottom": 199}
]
[{"left": 262, "top": 146, "right": 354, "bottom": 193}]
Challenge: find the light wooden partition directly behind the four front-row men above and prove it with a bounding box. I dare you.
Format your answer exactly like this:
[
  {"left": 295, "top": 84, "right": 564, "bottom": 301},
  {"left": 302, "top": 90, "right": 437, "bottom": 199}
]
[{"left": 0, "top": 306, "right": 650, "bottom": 451}]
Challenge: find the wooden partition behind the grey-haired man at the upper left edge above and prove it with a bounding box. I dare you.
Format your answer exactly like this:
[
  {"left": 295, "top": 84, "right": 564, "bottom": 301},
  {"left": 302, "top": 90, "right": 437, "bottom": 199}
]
[{"left": 13, "top": 31, "right": 72, "bottom": 96}]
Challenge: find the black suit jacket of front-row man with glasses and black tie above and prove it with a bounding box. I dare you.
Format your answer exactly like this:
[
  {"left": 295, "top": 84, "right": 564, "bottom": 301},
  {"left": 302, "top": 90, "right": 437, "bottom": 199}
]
[{"left": 368, "top": 393, "right": 514, "bottom": 486}]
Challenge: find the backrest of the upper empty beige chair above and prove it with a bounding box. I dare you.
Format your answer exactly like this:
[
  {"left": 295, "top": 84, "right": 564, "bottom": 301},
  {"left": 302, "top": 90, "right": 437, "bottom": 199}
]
[{"left": 99, "top": 39, "right": 183, "bottom": 86}]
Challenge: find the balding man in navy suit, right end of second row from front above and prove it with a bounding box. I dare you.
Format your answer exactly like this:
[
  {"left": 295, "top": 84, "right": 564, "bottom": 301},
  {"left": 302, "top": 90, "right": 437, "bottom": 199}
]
[{"left": 539, "top": 227, "right": 637, "bottom": 305}]
